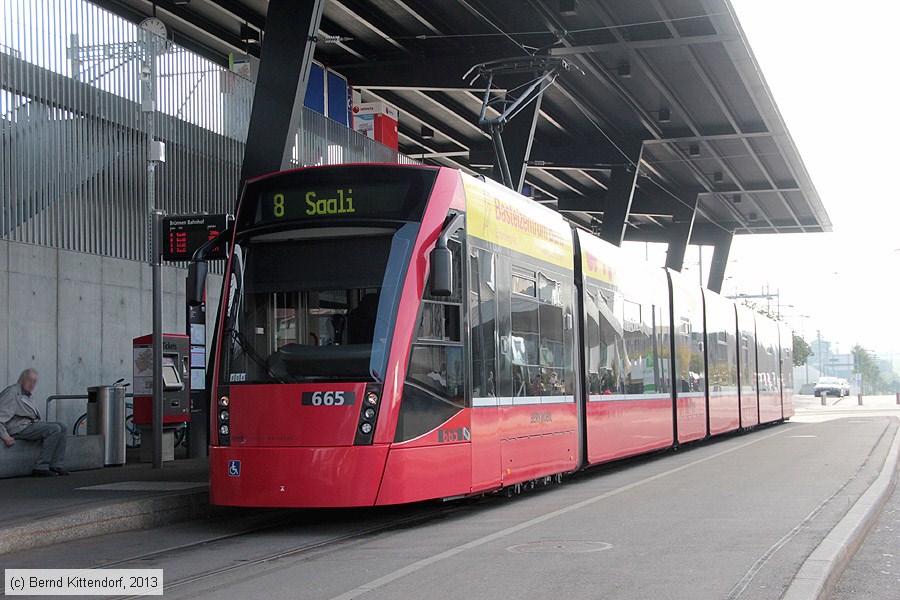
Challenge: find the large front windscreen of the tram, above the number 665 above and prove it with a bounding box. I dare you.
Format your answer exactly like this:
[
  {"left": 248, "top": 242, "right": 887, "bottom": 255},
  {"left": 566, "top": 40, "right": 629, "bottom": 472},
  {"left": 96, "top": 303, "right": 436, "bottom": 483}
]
[{"left": 221, "top": 228, "right": 407, "bottom": 383}]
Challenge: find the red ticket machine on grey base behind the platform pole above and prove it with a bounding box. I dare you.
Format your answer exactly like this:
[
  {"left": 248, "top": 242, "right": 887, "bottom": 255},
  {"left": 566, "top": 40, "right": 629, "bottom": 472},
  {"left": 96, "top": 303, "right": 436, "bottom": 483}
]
[{"left": 133, "top": 333, "right": 191, "bottom": 462}]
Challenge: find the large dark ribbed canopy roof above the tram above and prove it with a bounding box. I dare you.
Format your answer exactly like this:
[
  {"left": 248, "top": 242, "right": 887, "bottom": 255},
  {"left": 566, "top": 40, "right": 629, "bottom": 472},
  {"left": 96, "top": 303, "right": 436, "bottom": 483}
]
[{"left": 95, "top": 0, "right": 831, "bottom": 243}]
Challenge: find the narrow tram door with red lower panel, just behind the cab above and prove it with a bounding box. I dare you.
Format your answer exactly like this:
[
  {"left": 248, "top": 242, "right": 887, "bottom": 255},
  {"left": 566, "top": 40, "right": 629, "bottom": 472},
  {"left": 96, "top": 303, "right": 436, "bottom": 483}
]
[{"left": 468, "top": 244, "right": 502, "bottom": 490}]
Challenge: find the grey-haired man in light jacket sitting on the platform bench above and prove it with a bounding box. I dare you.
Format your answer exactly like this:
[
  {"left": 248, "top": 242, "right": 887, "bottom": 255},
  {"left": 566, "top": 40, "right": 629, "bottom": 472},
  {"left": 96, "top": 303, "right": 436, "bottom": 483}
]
[{"left": 0, "top": 369, "right": 69, "bottom": 477}]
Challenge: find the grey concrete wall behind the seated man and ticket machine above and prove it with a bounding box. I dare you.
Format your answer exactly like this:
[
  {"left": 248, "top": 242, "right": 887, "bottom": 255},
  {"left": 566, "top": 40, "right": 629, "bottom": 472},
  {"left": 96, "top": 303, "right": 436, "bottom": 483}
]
[{"left": 0, "top": 240, "right": 222, "bottom": 430}]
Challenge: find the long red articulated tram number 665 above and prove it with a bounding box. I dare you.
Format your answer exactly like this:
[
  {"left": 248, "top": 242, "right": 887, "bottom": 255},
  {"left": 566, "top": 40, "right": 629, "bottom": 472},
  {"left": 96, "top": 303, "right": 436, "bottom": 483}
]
[{"left": 210, "top": 165, "right": 793, "bottom": 507}]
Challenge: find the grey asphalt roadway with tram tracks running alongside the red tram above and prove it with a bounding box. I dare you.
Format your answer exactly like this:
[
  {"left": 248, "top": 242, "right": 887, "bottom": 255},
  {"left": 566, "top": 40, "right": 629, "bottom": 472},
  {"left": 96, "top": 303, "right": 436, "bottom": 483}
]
[{"left": 2, "top": 398, "right": 900, "bottom": 600}]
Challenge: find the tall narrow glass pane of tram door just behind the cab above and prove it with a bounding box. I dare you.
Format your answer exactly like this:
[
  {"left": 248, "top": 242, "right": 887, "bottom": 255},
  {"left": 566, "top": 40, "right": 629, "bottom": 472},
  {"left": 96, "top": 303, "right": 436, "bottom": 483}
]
[{"left": 469, "top": 248, "right": 497, "bottom": 398}]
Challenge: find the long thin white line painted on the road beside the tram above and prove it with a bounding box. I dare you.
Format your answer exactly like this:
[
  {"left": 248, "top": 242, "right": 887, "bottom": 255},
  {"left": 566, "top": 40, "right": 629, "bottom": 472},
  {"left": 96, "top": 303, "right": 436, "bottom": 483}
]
[{"left": 331, "top": 425, "right": 807, "bottom": 600}]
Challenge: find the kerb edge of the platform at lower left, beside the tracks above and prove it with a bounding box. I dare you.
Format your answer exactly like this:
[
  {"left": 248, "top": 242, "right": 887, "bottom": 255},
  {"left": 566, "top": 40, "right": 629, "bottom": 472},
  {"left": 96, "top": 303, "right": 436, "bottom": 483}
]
[{"left": 0, "top": 490, "right": 209, "bottom": 555}]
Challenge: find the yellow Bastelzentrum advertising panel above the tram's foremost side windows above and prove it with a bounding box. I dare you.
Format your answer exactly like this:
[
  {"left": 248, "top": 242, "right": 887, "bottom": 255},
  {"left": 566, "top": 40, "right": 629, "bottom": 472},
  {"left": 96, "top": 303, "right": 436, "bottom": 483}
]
[{"left": 463, "top": 174, "right": 575, "bottom": 270}]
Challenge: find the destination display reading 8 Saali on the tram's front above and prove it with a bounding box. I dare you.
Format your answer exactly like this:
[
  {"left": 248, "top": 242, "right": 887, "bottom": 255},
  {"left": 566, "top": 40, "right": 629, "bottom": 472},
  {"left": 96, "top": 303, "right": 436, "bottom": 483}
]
[{"left": 256, "top": 181, "right": 420, "bottom": 224}]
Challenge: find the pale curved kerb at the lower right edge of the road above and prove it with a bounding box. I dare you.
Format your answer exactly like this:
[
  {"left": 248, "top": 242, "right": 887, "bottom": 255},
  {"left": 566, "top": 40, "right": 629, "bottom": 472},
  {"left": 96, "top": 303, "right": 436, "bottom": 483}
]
[{"left": 781, "top": 420, "right": 900, "bottom": 600}]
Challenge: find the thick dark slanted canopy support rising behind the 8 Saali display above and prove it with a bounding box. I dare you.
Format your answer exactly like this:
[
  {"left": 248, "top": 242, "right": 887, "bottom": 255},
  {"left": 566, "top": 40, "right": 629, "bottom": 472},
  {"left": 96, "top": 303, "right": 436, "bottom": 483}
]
[{"left": 241, "top": 0, "right": 325, "bottom": 181}]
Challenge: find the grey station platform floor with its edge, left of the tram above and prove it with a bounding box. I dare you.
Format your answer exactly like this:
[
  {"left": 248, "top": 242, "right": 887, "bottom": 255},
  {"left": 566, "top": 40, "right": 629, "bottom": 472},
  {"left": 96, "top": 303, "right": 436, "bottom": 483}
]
[{"left": 0, "top": 459, "right": 209, "bottom": 555}]
